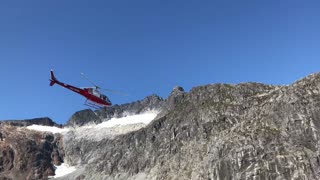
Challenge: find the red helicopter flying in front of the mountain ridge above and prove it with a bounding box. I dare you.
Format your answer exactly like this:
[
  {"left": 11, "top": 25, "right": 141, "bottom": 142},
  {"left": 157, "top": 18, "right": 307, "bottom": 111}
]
[{"left": 50, "top": 70, "right": 122, "bottom": 109}]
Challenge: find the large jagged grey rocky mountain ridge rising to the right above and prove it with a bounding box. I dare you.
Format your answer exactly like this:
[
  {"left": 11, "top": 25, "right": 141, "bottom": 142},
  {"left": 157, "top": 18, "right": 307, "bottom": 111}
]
[{"left": 0, "top": 73, "right": 320, "bottom": 180}]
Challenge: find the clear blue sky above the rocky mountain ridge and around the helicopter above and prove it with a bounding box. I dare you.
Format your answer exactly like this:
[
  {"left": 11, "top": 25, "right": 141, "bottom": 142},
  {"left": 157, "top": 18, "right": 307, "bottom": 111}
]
[{"left": 0, "top": 0, "right": 320, "bottom": 123}]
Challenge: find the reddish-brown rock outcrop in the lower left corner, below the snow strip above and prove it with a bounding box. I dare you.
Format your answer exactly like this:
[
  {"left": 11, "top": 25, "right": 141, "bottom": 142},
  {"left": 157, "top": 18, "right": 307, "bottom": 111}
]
[{"left": 0, "top": 124, "right": 63, "bottom": 180}]
